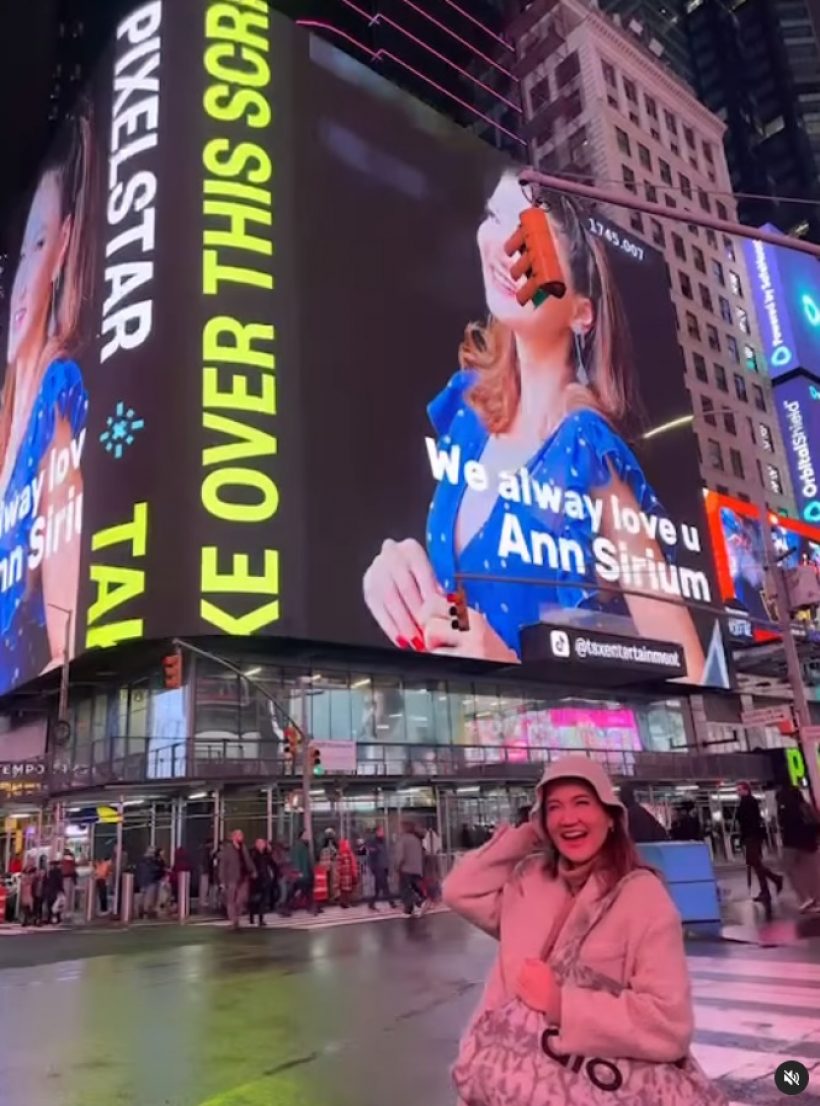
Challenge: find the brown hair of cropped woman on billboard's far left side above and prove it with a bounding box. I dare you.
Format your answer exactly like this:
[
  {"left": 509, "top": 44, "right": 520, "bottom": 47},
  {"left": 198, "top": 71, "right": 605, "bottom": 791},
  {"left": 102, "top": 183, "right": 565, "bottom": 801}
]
[{"left": 0, "top": 100, "right": 94, "bottom": 458}]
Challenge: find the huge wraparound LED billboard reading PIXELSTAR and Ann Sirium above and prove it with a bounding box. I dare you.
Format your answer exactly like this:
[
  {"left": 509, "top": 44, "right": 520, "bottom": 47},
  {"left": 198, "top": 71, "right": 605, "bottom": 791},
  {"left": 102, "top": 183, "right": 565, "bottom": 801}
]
[{"left": 0, "top": 0, "right": 728, "bottom": 690}]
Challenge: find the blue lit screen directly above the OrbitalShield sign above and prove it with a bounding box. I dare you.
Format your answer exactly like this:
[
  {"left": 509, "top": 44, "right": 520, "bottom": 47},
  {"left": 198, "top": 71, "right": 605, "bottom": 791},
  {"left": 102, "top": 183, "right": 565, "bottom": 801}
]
[{"left": 744, "top": 226, "right": 820, "bottom": 378}]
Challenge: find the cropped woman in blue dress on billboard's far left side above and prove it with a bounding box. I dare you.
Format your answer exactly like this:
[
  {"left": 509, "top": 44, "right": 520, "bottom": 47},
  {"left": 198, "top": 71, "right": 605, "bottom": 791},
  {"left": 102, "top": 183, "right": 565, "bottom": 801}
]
[{"left": 0, "top": 105, "right": 92, "bottom": 691}]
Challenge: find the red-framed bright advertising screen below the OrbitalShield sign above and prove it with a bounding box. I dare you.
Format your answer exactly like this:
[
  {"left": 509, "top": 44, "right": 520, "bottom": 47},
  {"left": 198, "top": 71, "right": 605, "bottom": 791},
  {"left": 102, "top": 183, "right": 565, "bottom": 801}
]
[{"left": 706, "top": 491, "right": 820, "bottom": 644}]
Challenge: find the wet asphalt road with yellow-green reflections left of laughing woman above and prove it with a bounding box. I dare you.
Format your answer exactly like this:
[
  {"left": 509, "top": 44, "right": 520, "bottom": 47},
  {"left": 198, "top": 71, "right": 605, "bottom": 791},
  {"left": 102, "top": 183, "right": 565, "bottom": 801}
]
[{"left": 0, "top": 916, "right": 486, "bottom": 1106}]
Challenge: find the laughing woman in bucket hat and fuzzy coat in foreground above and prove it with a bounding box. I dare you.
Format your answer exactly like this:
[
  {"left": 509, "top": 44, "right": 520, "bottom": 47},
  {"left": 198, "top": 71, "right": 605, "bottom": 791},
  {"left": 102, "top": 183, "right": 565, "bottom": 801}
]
[{"left": 444, "top": 757, "right": 725, "bottom": 1106}]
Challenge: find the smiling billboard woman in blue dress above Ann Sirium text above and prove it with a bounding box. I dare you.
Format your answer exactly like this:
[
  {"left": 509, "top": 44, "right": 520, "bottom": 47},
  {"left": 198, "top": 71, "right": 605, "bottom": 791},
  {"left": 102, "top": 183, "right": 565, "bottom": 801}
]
[{"left": 364, "top": 171, "right": 705, "bottom": 682}]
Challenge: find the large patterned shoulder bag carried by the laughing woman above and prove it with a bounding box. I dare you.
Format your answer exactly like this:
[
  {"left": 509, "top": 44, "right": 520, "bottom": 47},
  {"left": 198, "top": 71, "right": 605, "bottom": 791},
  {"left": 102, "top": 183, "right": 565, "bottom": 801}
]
[{"left": 453, "top": 873, "right": 728, "bottom": 1106}]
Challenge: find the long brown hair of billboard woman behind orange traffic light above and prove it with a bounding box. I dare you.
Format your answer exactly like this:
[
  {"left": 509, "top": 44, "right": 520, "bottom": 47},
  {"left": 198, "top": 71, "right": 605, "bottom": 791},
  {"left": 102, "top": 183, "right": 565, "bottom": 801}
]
[{"left": 459, "top": 173, "right": 636, "bottom": 434}]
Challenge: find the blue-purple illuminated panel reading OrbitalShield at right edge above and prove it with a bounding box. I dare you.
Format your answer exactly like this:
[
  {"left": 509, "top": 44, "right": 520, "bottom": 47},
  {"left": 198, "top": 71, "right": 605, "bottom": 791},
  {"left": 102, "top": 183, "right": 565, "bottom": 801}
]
[{"left": 775, "top": 373, "right": 820, "bottom": 524}]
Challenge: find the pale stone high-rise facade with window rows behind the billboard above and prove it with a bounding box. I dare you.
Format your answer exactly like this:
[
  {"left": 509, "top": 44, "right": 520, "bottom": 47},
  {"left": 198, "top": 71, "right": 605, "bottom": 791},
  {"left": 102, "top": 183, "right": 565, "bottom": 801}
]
[{"left": 512, "top": 0, "right": 795, "bottom": 514}]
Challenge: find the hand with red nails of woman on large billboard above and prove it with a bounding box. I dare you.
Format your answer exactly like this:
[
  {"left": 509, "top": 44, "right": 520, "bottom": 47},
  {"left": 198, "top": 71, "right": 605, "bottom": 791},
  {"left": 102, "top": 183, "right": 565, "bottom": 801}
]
[{"left": 363, "top": 538, "right": 444, "bottom": 653}]
